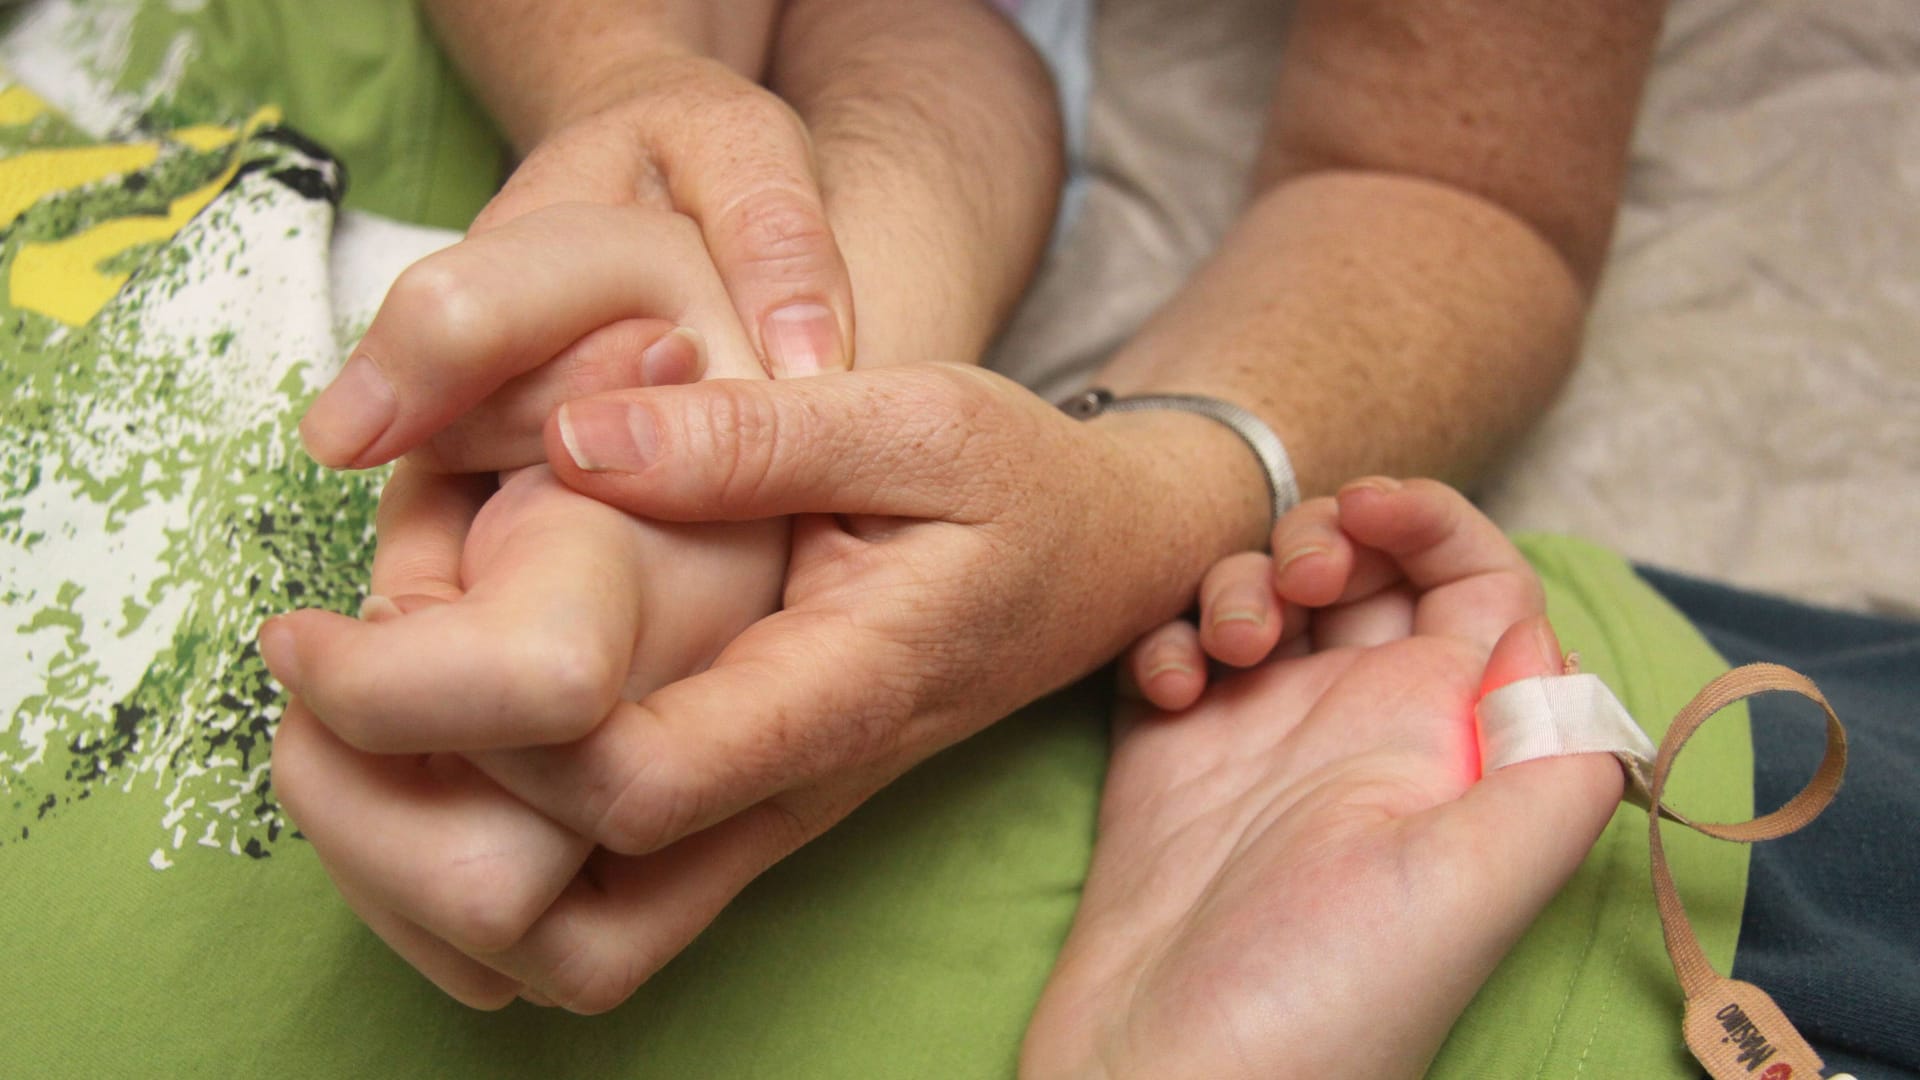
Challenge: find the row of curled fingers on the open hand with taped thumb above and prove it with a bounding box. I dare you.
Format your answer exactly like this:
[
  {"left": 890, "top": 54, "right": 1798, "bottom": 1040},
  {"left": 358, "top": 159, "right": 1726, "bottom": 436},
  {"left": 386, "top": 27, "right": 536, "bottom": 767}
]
[{"left": 1123, "top": 477, "right": 1540, "bottom": 711}]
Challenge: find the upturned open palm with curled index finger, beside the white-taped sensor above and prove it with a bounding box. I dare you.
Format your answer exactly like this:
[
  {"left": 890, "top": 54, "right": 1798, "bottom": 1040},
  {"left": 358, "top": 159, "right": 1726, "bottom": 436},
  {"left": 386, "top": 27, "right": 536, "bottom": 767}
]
[{"left": 1021, "top": 482, "right": 1620, "bottom": 1080}]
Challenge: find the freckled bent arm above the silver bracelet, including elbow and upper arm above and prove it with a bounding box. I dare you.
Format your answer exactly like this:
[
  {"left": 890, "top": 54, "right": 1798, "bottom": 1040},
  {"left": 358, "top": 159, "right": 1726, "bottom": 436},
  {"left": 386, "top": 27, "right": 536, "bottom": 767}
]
[{"left": 1104, "top": 0, "right": 1661, "bottom": 564}]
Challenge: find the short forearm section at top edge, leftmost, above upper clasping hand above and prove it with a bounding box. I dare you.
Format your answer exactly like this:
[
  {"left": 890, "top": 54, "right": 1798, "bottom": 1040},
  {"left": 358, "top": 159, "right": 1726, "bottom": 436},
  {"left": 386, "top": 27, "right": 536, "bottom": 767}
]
[{"left": 422, "top": 0, "right": 780, "bottom": 154}]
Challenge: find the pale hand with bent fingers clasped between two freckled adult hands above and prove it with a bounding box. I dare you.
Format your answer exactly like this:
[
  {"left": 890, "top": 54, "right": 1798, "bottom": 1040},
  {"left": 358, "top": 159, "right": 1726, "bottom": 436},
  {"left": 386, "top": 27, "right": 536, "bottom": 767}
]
[{"left": 261, "top": 195, "right": 787, "bottom": 1005}]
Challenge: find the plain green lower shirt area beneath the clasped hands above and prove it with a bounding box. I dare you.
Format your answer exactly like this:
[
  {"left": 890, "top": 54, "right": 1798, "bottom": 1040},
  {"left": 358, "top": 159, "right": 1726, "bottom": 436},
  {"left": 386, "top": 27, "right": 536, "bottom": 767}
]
[{"left": 0, "top": 692, "right": 1106, "bottom": 1080}]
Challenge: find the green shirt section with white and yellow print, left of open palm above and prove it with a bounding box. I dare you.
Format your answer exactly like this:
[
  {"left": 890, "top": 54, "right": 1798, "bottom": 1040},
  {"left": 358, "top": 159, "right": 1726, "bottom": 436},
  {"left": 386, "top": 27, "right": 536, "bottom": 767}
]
[{"left": 0, "top": 50, "right": 1108, "bottom": 1078}]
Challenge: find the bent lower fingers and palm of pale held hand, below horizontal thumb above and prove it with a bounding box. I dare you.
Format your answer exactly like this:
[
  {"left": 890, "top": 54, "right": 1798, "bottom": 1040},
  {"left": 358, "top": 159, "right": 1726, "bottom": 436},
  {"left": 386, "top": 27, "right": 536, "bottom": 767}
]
[{"left": 261, "top": 463, "right": 787, "bottom": 1005}]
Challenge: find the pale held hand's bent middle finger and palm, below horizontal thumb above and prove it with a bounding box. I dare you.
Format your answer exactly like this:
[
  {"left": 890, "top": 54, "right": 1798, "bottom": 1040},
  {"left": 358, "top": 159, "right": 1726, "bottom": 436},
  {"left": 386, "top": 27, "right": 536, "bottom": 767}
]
[{"left": 263, "top": 465, "right": 787, "bottom": 753}]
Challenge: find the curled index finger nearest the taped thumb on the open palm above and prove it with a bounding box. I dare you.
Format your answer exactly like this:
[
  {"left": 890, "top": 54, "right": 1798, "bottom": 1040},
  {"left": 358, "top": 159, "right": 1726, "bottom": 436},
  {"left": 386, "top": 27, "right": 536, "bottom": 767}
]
[{"left": 1338, "top": 479, "right": 1546, "bottom": 650}]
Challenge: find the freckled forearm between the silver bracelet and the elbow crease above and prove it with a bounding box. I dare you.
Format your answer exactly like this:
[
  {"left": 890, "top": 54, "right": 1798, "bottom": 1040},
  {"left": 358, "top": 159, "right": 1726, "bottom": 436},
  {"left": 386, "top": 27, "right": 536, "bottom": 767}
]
[{"left": 1102, "top": 173, "right": 1584, "bottom": 494}]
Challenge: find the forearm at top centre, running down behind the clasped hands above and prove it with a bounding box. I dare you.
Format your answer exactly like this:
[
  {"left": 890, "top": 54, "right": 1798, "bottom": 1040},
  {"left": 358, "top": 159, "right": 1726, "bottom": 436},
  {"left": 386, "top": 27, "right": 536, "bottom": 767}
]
[{"left": 772, "top": 0, "right": 1062, "bottom": 367}]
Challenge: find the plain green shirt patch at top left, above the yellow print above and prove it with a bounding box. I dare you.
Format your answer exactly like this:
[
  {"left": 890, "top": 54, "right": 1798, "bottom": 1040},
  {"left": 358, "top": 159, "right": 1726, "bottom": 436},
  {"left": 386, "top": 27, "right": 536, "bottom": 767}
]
[{"left": 106, "top": 0, "right": 505, "bottom": 229}]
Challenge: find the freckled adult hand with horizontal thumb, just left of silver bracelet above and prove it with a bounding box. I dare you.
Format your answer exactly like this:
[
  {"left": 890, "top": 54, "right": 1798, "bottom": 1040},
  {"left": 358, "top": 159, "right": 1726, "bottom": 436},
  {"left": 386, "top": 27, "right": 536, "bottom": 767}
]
[{"left": 263, "top": 365, "right": 1261, "bottom": 1011}]
